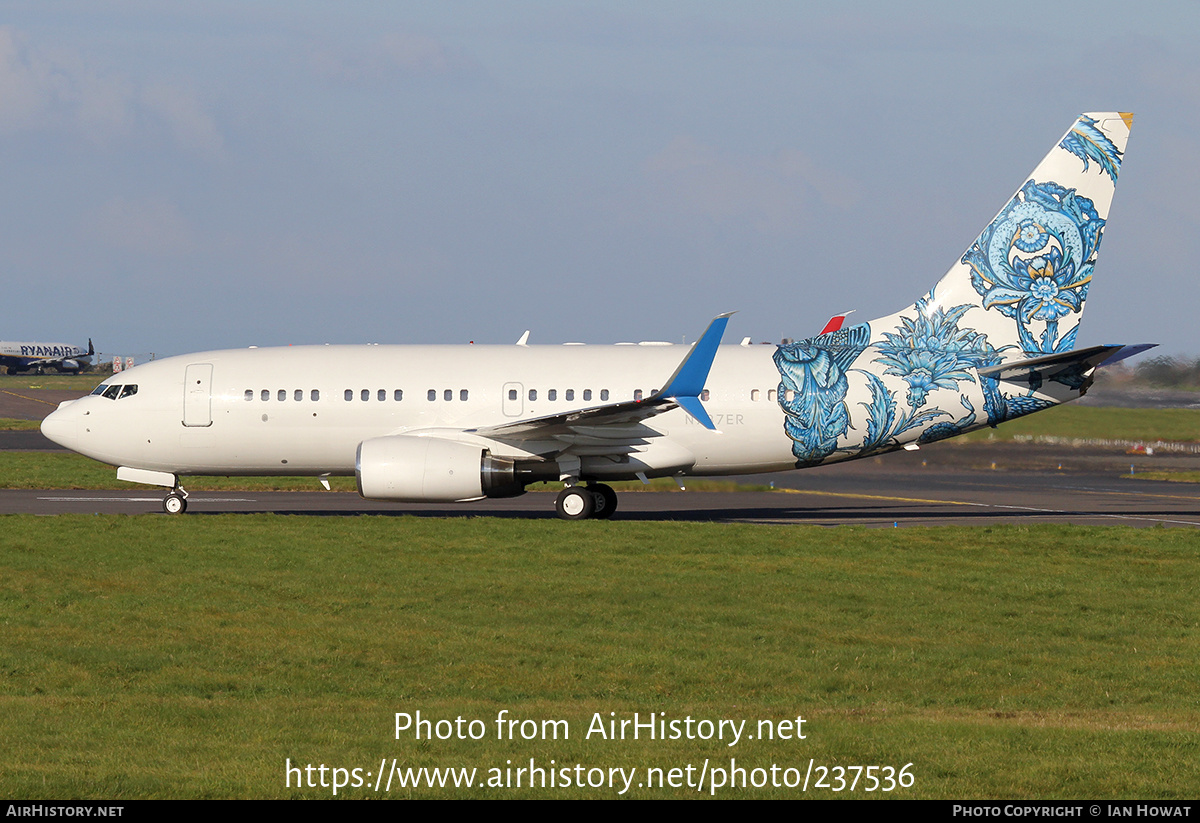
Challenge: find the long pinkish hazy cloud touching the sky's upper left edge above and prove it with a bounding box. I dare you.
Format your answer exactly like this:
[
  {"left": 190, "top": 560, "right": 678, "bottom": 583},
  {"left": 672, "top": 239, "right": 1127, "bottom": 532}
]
[{"left": 0, "top": 26, "right": 223, "bottom": 158}]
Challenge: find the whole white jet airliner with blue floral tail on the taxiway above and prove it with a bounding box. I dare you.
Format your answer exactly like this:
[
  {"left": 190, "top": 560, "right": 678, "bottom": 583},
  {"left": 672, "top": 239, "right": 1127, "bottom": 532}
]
[{"left": 42, "top": 112, "right": 1145, "bottom": 519}]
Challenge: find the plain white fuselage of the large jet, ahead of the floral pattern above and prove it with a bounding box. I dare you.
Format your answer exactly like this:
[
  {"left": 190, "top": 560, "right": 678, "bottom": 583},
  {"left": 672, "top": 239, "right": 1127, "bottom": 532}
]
[{"left": 43, "top": 346, "right": 796, "bottom": 479}]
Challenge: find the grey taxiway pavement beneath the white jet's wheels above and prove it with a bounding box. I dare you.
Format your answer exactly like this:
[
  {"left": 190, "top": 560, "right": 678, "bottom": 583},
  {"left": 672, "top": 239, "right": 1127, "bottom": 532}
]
[{"left": 0, "top": 457, "right": 1200, "bottom": 528}]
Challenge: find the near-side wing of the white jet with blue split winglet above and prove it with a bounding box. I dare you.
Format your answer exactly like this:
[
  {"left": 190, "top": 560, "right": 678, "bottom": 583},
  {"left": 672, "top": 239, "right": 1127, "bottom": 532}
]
[{"left": 464, "top": 312, "right": 733, "bottom": 445}]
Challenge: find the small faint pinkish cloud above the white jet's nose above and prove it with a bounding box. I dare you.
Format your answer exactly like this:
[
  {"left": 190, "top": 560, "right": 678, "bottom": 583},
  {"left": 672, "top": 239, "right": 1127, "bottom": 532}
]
[{"left": 84, "top": 197, "right": 194, "bottom": 257}]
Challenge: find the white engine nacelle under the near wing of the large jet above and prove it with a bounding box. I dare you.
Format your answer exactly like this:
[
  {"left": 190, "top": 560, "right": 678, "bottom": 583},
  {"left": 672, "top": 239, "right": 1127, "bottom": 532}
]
[{"left": 354, "top": 434, "right": 524, "bottom": 503}]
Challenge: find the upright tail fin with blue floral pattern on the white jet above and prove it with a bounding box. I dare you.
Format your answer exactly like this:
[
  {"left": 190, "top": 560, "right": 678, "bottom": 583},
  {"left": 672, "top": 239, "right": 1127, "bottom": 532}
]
[{"left": 912, "top": 112, "right": 1133, "bottom": 360}]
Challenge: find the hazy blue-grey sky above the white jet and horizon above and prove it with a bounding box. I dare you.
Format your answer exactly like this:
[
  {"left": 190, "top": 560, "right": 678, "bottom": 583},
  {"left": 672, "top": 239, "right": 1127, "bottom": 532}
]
[{"left": 0, "top": 0, "right": 1200, "bottom": 359}]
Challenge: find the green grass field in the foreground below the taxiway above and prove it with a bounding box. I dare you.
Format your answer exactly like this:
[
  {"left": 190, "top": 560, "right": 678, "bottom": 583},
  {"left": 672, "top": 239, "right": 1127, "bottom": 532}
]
[{"left": 0, "top": 523, "right": 1200, "bottom": 799}]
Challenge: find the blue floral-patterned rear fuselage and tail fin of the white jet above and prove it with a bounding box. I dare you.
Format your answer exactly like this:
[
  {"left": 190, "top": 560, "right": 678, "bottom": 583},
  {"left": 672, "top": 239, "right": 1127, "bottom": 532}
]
[{"left": 775, "top": 112, "right": 1133, "bottom": 467}]
